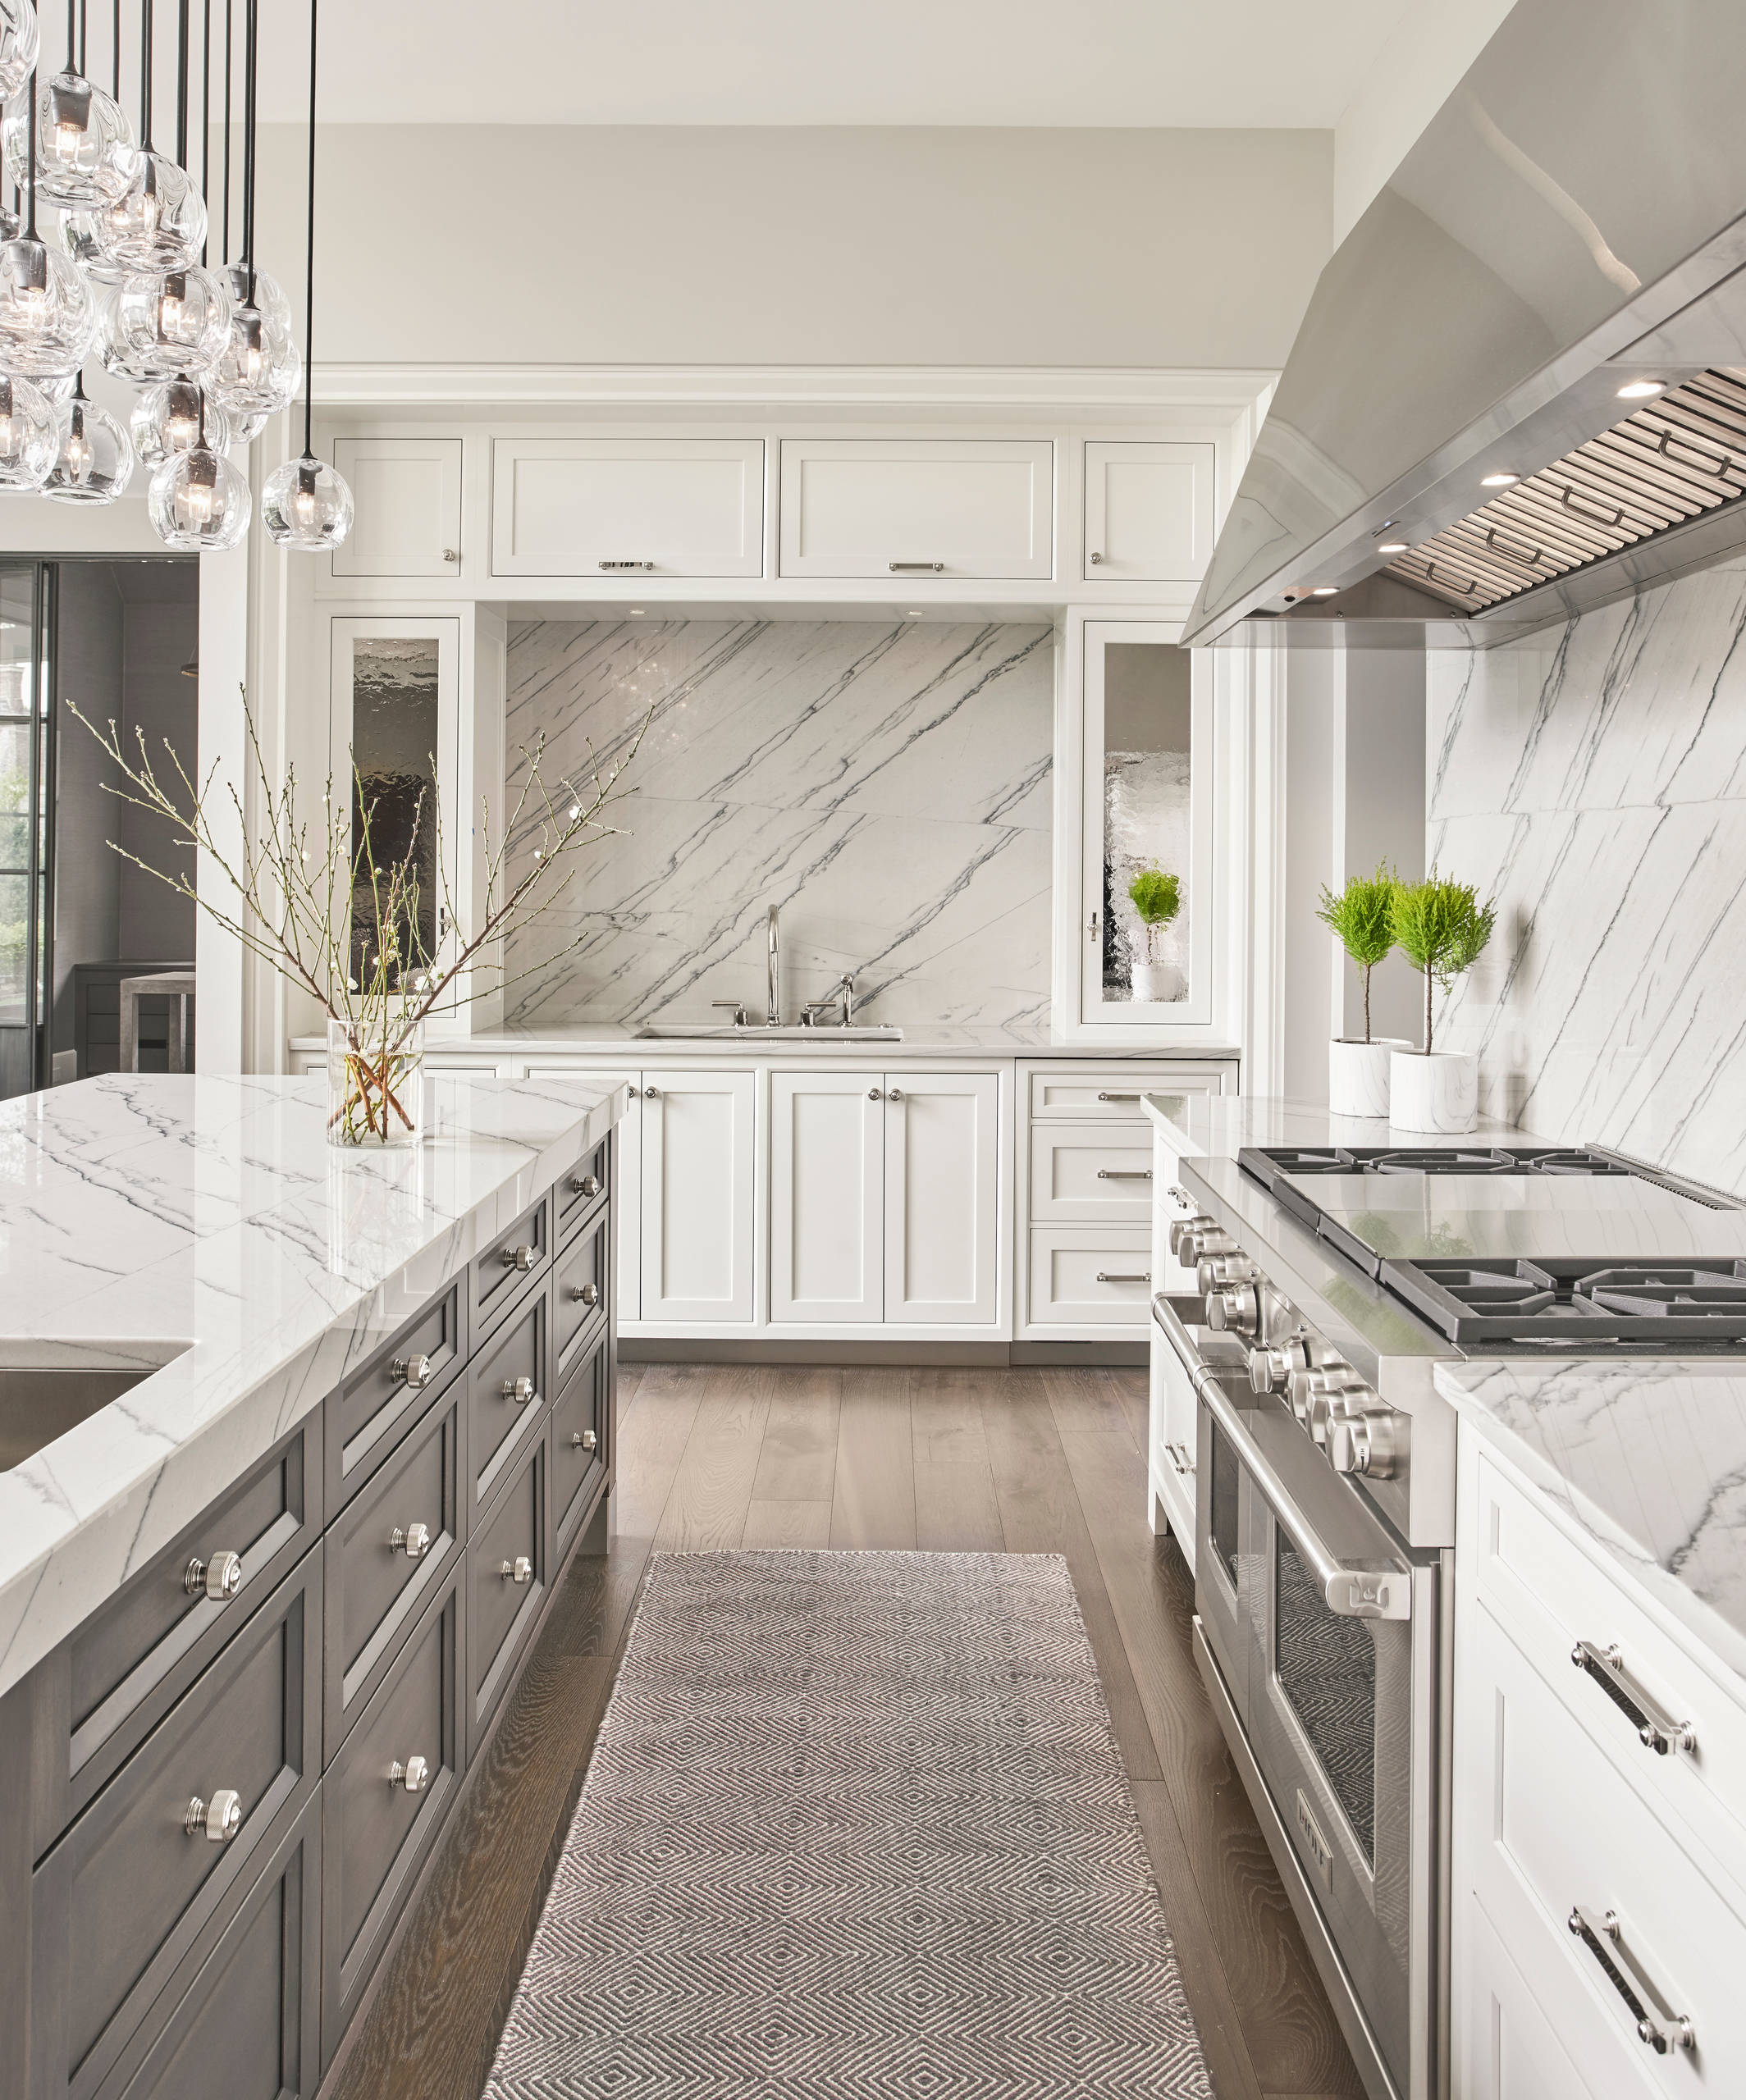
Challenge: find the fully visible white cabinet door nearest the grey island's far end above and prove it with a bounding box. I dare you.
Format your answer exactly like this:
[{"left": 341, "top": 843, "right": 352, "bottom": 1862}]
[{"left": 641, "top": 1071, "right": 756, "bottom": 1325}]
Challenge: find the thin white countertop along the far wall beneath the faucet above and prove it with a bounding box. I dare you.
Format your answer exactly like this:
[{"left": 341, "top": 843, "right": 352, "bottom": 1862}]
[{"left": 290, "top": 1014, "right": 1243, "bottom": 1058}]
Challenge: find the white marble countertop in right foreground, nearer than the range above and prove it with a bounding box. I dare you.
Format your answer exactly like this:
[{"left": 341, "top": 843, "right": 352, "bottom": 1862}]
[{"left": 1433, "top": 1357, "right": 1746, "bottom": 1695}]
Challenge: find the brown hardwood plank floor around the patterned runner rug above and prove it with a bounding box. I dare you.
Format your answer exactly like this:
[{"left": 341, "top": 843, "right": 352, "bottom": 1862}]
[{"left": 332, "top": 1365, "right": 1364, "bottom": 2100}]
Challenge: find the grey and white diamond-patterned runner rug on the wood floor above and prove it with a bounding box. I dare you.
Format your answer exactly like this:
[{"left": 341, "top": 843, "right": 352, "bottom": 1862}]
[{"left": 486, "top": 1552, "right": 1213, "bottom": 2100}]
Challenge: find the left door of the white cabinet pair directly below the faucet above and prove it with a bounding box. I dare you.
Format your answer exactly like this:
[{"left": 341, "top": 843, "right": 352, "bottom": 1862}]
[{"left": 769, "top": 1071, "right": 884, "bottom": 1321}]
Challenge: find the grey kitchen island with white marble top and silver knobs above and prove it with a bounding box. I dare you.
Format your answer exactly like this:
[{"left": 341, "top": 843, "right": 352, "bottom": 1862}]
[{"left": 0, "top": 1075, "right": 626, "bottom": 2100}]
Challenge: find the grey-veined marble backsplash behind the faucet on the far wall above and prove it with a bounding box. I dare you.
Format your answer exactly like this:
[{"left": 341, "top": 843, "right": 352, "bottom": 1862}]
[{"left": 506, "top": 619, "right": 1055, "bottom": 1025}]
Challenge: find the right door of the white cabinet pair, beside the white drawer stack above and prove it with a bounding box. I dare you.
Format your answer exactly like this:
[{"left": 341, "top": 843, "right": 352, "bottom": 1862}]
[{"left": 884, "top": 1071, "right": 1000, "bottom": 1327}]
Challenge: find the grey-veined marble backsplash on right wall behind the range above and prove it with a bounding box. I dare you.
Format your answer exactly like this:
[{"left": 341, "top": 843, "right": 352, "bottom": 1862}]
[{"left": 1428, "top": 561, "right": 1746, "bottom": 1191}]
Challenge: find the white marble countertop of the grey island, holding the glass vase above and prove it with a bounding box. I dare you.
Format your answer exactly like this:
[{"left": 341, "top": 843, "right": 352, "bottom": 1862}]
[{"left": 0, "top": 1073, "right": 626, "bottom": 1692}]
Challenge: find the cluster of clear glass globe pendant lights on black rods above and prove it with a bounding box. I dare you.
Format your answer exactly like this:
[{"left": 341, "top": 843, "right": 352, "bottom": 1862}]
[{"left": 0, "top": 0, "right": 353, "bottom": 552}]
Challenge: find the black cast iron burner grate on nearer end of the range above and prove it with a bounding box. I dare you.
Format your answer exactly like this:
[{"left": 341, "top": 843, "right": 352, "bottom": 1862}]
[{"left": 1380, "top": 1256, "right": 1746, "bottom": 1349}]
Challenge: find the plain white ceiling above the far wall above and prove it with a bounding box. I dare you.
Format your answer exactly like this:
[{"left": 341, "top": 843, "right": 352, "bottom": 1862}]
[{"left": 239, "top": 0, "right": 1403, "bottom": 128}]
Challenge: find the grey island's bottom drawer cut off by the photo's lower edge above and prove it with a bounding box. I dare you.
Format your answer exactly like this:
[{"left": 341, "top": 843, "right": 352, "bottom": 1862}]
[{"left": 103, "top": 1801, "right": 322, "bottom": 2100}]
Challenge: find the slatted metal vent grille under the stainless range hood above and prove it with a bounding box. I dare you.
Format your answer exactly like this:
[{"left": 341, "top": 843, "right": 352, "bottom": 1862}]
[{"left": 1387, "top": 365, "right": 1746, "bottom": 614}]
